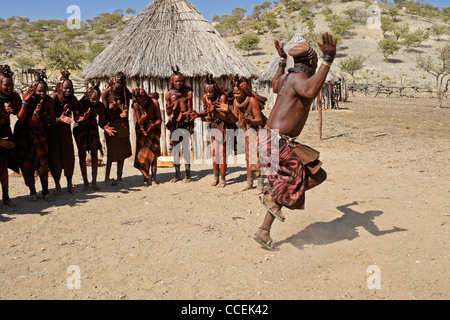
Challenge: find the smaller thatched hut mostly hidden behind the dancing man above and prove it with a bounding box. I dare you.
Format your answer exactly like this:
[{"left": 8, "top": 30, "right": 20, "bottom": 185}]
[{"left": 254, "top": 27, "right": 341, "bottom": 109}]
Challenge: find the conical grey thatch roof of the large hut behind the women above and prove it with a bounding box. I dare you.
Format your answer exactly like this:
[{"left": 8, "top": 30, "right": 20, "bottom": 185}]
[{"left": 82, "top": 0, "right": 258, "bottom": 80}]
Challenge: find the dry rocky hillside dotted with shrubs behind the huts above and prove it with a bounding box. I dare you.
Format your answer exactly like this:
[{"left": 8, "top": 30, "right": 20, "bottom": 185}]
[{"left": 0, "top": 0, "right": 450, "bottom": 88}]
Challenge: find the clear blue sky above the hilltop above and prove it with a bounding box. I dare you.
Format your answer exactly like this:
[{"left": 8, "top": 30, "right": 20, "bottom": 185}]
[{"left": 0, "top": 0, "right": 450, "bottom": 21}]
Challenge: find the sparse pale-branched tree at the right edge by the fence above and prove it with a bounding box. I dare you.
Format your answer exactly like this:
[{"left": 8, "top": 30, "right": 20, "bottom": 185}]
[{"left": 416, "top": 44, "right": 450, "bottom": 108}]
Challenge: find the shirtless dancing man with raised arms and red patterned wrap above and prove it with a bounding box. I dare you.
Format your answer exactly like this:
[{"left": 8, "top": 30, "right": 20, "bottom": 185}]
[{"left": 253, "top": 33, "right": 337, "bottom": 250}]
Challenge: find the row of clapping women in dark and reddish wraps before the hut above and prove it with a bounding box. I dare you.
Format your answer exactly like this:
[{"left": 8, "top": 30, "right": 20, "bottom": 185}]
[{"left": 0, "top": 65, "right": 266, "bottom": 207}]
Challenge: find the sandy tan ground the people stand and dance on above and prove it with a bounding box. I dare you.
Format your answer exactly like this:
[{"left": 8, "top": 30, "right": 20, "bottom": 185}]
[{"left": 0, "top": 97, "right": 450, "bottom": 300}]
